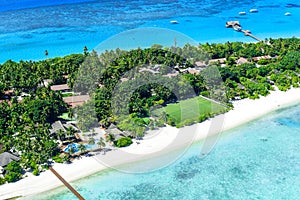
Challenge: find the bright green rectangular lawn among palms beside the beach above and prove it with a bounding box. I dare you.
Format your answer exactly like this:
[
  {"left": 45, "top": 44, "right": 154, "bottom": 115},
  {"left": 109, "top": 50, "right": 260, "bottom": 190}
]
[{"left": 154, "top": 97, "right": 226, "bottom": 124}]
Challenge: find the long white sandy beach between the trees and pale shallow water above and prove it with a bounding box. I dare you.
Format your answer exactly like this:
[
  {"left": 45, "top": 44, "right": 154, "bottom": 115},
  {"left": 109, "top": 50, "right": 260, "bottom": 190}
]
[{"left": 0, "top": 88, "right": 300, "bottom": 199}]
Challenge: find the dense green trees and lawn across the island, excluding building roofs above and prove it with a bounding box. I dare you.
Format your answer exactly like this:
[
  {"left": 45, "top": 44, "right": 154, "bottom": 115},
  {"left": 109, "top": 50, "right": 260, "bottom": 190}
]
[{"left": 0, "top": 38, "right": 300, "bottom": 183}]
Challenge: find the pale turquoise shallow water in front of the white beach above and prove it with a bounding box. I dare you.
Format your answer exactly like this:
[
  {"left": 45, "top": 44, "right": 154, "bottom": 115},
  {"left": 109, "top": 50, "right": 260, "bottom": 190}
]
[{"left": 30, "top": 104, "right": 300, "bottom": 200}]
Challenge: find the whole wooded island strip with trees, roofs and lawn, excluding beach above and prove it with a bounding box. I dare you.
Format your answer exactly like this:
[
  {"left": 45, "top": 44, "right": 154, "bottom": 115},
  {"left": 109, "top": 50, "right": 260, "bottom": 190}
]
[{"left": 0, "top": 38, "right": 300, "bottom": 198}]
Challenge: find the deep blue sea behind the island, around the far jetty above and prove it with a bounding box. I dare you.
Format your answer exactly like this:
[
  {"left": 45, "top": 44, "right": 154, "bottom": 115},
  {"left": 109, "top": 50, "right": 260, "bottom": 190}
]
[{"left": 0, "top": 0, "right": 300, "bottom": 63}]
